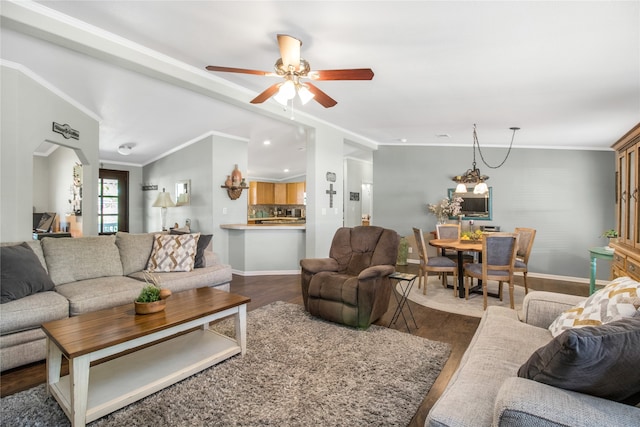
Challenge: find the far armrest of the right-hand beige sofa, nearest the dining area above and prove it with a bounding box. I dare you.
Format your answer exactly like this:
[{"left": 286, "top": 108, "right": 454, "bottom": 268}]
[{"left": 521, "top": 291, "right": 585, "bottom": 329}]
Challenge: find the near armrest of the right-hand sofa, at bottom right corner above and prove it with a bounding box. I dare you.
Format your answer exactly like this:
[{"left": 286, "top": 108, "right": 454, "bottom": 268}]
[{"left": 493, "top": 377, "right": 640, "bottom": 427}]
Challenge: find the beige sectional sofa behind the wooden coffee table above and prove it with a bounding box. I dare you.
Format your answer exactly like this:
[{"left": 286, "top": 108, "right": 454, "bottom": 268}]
[{"left": 0, "top": 233, "right": 232, "bottom": 371}]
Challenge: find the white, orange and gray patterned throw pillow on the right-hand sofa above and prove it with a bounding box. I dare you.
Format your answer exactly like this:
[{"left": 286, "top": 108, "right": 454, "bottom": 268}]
[{"left": 549, "top": 277, "right": 640, "bottom": 337}]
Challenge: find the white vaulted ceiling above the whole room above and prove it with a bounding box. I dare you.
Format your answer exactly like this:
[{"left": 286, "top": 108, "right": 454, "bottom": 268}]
[{"left": 0, "top": 1, "right": 640, "bottom": 179}]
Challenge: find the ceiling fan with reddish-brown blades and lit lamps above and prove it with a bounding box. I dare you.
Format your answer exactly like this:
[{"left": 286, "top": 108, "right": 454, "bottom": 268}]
[{"left": 206, "top": 34, "right": 373, "bottom": 108}]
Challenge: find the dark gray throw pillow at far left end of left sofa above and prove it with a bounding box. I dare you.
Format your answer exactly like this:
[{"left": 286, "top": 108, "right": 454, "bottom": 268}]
[{"left": 0, "top": 243, "right": 55, "bottom": 304}]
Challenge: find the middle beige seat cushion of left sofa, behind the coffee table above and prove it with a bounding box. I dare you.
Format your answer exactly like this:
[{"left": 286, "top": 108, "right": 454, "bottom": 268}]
[{"left": 56, "top": 276, "right": 145, "bottom": 316}]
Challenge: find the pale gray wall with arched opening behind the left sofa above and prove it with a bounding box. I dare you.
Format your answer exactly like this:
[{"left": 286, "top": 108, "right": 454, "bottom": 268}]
[{"left": 0, "top": 65, "right": 98, "bottom": 242}]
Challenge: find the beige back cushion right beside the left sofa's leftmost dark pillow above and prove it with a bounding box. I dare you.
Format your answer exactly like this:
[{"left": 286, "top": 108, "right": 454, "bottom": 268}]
[{"left": 42, "top": 235, "right": 122, "bottom": 286}]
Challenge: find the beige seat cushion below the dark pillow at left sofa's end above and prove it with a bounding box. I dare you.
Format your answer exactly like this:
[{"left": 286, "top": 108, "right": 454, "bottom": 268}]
[{"left": 0, "top": 290, "right": 69, "bottom": 335}]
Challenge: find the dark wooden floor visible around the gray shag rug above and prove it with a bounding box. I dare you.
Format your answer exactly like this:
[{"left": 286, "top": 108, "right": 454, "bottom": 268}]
[{"left": 0, "top": 270, "right": 580, "bottom": 426}]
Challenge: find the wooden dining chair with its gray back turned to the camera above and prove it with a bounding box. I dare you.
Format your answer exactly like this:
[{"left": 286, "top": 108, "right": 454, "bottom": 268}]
[{"left": 464, "top": 233, "right": 518, "bottom": 310}]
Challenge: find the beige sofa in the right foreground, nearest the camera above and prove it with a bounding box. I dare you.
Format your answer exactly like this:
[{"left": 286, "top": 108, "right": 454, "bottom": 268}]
[{"left": 425, "top": 291, "right": 640, "bottom": 427}]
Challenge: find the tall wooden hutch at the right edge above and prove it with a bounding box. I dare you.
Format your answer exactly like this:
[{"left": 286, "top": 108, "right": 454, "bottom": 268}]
[{"left": 610, "top": 123, "right": 640, "bottom": 280}]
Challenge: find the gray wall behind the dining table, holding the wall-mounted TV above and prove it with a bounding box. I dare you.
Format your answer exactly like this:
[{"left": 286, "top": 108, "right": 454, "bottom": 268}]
[{"left": 373, "top": 146, "right": 615, "bottom": 279}]
